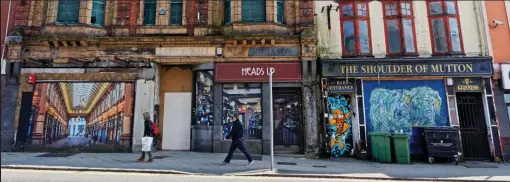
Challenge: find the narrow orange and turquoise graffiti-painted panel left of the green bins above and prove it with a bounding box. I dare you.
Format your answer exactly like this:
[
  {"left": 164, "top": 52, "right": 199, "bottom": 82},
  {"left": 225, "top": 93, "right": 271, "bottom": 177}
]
[{"left": 328, "top": 96, "right": 352, "bottom": 157}]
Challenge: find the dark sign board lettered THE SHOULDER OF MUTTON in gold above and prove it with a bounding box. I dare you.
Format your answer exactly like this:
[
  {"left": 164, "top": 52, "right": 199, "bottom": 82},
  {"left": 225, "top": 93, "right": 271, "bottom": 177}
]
[{"left": 322, "top": 60, "right": 493, "bottom": 77}]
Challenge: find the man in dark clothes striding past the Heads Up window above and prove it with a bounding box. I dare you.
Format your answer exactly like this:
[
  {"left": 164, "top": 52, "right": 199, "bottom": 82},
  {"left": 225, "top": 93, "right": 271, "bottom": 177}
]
[{"left": 222, "top": 113, "right": 254, "bottom": 166}]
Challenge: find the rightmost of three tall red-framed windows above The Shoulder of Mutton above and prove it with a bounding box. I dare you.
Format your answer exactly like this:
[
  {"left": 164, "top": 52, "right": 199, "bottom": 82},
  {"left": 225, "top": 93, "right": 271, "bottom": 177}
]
[{"left": 427, "top": 1, "right": 464, "bottom": 54}]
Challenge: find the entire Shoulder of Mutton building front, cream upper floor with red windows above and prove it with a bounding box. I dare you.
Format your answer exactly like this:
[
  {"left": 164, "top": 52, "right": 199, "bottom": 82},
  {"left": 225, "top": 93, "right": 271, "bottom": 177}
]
[{"left": 315, "top": 0, "right": 501, "bottom": 160}]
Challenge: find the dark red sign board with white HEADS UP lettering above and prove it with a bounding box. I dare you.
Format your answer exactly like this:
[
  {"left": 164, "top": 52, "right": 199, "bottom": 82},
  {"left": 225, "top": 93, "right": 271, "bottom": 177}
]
[{"left": 214, "top": 62, "right": 301, "bottom": 82}]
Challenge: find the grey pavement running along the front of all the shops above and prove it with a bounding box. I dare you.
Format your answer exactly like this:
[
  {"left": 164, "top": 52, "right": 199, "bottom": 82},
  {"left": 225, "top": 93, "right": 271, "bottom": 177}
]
[{"left": 1, "top": 151, "right": 510, "bottom": 181}]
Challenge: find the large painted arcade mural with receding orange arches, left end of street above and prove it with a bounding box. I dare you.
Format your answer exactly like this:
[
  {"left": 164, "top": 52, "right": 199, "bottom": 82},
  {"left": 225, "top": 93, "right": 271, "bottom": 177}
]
[{"left": 26, "top": 82, "right": 134, "bottom": 152}]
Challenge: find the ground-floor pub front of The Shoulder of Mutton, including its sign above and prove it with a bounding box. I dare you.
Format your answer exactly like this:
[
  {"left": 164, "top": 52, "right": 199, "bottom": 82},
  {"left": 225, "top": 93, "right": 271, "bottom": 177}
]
[{"left": 322, "top": 57, "right": 495, "bottom": 159}]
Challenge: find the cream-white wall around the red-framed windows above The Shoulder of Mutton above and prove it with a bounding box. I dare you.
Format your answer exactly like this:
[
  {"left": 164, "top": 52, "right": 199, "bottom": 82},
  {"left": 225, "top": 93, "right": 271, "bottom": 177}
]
[{"left": 314, "top": 0, "right": 487, "bottom": 59}]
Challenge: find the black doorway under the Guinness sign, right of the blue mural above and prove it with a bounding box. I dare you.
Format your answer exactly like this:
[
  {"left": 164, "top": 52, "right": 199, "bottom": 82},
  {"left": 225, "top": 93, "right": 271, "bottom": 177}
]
[{"left": 457, "top": 93, "right": 490, "bottom": 160}]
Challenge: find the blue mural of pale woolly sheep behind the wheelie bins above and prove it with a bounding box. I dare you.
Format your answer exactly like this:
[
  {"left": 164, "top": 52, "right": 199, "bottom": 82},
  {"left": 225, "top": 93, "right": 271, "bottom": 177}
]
[{"left": 363, "top": 80, "right": 448, "bottom": 134}]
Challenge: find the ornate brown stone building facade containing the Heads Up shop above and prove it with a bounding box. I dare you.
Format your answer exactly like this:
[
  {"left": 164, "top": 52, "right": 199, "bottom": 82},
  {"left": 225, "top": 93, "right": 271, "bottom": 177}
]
[{"left": 7, "top": 0, "right": 319, "bottom": 156}]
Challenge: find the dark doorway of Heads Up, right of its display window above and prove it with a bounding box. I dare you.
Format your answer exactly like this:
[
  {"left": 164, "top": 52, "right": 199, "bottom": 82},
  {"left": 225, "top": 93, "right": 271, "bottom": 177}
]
[{"left": 273, "top": 88, "right": 303, "bottom": 154}]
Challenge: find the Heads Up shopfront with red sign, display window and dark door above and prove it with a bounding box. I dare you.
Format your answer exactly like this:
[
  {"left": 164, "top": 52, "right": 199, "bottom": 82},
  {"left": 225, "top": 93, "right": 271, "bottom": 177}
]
[{"left": 209, "top": 62, "right": 303, "bottom": 154}]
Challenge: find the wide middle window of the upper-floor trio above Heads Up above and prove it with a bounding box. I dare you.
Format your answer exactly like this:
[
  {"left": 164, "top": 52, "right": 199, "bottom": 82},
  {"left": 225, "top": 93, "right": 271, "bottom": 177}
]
[{"left": 241, "top": 0, "right": 266, "bottom": 22}]
